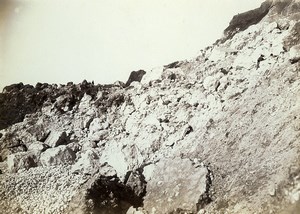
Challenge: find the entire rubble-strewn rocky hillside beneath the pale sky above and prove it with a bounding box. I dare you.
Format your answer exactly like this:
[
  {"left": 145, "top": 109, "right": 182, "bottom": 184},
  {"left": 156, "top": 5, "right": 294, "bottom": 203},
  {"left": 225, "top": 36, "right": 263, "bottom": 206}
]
[{"left": 0, "top": 0, "right": 300, "bottom": 214}]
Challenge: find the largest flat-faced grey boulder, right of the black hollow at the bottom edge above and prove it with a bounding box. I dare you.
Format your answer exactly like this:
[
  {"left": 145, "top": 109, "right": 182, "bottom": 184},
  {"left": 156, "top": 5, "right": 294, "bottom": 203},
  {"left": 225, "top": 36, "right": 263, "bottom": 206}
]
[{"left": 144, "top": 158, "right": 209, "bottom": 213}]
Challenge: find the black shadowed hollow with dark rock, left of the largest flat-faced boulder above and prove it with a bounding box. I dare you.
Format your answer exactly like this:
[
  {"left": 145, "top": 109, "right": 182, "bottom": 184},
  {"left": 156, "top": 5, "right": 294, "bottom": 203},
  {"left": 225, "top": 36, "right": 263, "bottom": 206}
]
[{"left": 86, "top": 171, "right": 146, "bottom": 214}]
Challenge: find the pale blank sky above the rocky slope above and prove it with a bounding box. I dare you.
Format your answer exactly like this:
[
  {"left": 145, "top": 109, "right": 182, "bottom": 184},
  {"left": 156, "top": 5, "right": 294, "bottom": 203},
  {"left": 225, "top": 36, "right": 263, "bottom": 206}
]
[{"left": 0, "top": 0, "right": 263, "bottom": 90}]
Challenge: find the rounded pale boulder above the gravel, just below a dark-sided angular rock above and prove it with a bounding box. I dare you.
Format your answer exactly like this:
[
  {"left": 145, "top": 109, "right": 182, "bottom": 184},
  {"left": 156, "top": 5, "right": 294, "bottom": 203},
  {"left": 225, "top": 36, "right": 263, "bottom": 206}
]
[{"left": 40, "top": 145, "right": 76, "bottom": 166}]
